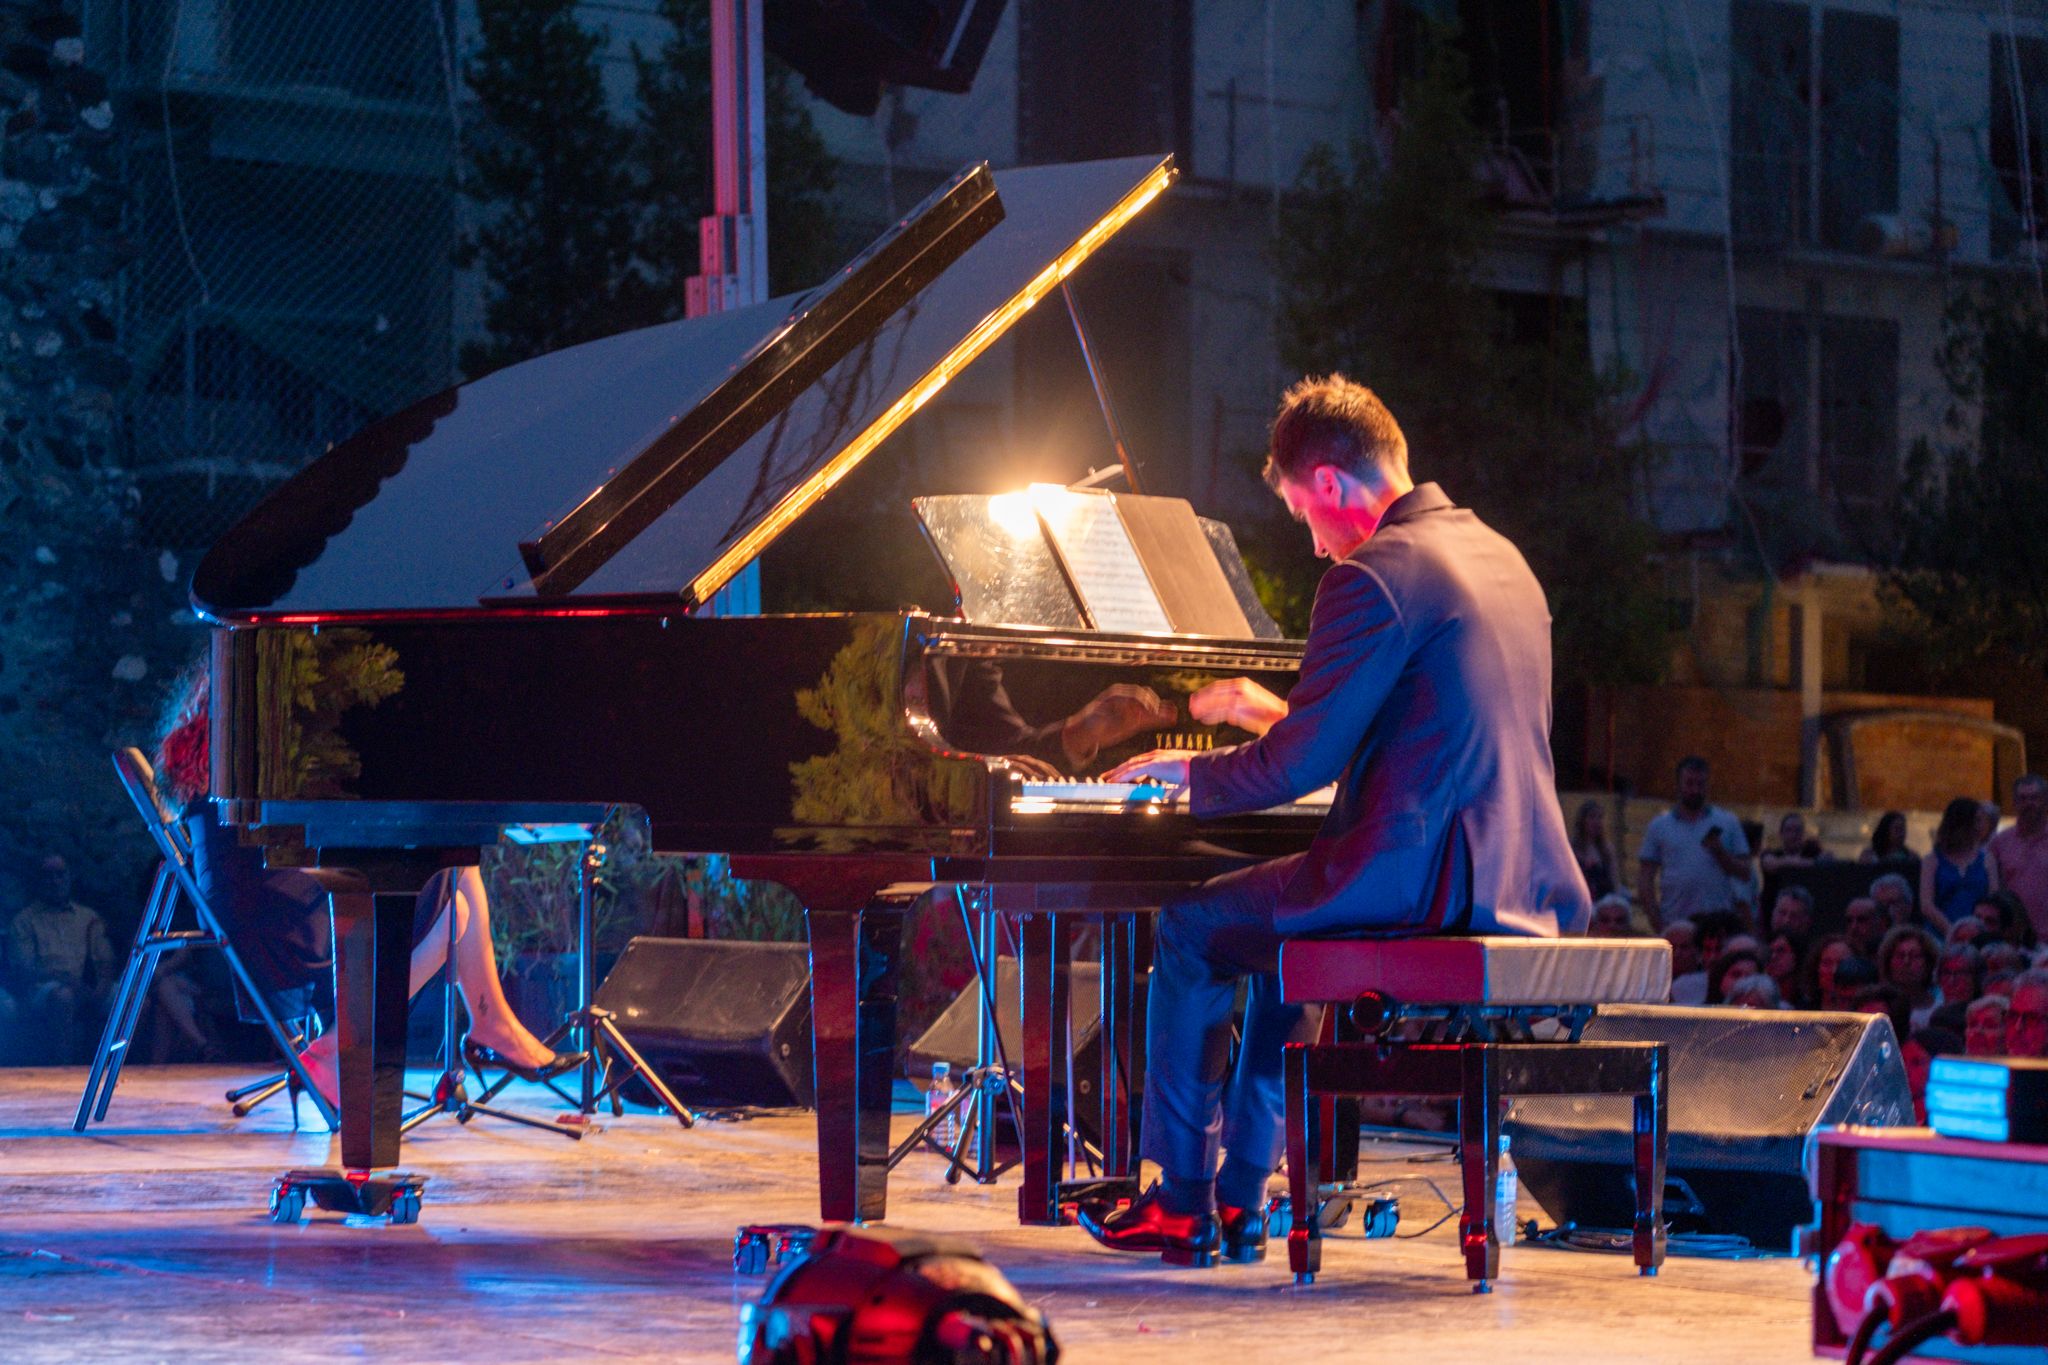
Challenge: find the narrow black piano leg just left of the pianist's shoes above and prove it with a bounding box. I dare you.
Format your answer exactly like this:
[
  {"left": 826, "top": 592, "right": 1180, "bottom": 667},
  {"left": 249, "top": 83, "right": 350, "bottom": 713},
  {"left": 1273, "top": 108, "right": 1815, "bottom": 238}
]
[{"left": 1018, "top": 913, "right": 1073, "bottom": 1226}]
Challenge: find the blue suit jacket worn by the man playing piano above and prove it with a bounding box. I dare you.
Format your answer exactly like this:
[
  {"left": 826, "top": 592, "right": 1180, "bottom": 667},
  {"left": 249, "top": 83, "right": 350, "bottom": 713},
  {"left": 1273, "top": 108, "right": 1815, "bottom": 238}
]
[{"left": 1188, "top": 483, "right": 1591, "bottom": 935}]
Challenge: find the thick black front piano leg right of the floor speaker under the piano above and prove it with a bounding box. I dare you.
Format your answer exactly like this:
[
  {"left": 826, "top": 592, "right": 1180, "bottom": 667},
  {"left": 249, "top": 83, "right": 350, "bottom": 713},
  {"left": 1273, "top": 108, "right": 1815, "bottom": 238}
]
[{"left": 805, "top": 888, "right": 922, "bottom": 1222}]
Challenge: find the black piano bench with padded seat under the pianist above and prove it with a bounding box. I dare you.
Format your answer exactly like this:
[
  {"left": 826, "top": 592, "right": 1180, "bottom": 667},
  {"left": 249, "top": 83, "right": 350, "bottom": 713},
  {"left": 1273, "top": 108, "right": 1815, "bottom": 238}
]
[{"left": 1280, "top": 937, "right": 1671, "bottom": 1293}]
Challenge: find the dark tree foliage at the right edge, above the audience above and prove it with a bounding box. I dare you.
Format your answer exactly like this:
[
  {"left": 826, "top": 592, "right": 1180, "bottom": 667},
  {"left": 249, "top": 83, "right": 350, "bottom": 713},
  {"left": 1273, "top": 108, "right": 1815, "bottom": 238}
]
[{"left": 1886, "top": 289, "right": 2048, "bottom": 673}]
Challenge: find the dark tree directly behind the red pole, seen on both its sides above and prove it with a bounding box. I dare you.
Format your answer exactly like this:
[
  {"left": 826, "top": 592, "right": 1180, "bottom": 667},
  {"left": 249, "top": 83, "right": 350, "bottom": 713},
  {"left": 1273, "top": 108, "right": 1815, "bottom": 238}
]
[{"left": 631, "top": 0, "right": 848, "bottom": 323}]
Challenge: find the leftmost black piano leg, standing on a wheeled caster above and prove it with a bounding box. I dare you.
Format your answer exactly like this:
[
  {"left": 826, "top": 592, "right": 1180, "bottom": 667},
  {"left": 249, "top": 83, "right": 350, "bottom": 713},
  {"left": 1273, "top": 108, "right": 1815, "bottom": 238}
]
[{"left": 330, "top": 888, "right": 416, "bottom": 1171}]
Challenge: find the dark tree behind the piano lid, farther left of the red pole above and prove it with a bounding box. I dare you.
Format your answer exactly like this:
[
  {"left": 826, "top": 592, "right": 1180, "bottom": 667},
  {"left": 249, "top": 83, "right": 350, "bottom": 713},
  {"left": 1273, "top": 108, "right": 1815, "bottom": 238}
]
[{"left": 457, "top": 0, "right": 637, "bottom": 377}]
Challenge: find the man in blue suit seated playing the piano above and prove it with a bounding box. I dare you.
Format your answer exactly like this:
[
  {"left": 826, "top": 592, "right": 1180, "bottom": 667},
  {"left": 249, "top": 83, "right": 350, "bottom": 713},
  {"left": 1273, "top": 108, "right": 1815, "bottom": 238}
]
[{"left": 1081, "top": 375, "right": 1591, "bottom": 1265}]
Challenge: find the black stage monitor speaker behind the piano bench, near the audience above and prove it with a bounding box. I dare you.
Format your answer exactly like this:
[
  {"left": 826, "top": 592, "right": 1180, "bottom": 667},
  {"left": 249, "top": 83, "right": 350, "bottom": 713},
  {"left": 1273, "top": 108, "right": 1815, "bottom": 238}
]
[{"left": 1507, "top": 1005, "right": 1913, "bottom": 1250}]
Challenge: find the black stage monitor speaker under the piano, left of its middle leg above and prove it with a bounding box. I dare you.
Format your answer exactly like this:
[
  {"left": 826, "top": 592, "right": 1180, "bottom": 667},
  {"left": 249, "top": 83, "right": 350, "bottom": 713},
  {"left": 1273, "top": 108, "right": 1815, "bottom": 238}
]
[{"left": 596, "top": 937, "right": 815, "bottom": 1109}]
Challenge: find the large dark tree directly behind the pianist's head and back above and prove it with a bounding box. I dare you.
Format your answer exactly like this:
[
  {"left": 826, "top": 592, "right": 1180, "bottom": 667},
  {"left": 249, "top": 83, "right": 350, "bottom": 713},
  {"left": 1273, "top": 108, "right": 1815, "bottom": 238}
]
[{"left": 1278, "top": 35, "right": 1667, "bottom": 696}]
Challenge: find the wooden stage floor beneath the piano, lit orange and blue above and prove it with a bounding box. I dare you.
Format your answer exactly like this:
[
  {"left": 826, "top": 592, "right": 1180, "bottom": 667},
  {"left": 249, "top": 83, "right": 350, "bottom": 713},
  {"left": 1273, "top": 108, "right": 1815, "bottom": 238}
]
[{"left": 0, "top": 1066, "right": 1812, "bottom": 1365}]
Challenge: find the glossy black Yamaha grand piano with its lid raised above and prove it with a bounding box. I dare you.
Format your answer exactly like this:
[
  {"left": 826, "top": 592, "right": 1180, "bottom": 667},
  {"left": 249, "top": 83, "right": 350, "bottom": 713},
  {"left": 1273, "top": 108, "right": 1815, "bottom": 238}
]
[{"left": 193, "top": 158, "right": 1319, "bottom": 1222}]
